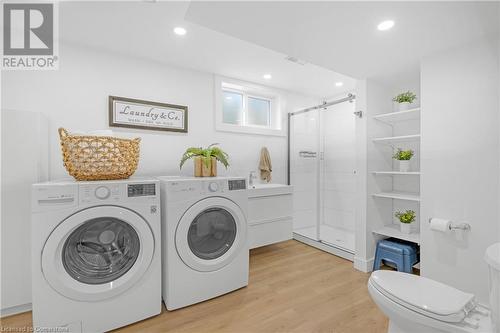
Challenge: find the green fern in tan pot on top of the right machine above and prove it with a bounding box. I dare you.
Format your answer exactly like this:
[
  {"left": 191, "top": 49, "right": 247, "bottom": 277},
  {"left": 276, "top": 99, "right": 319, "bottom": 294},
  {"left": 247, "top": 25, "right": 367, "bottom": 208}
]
[{"left": 179, "top": 143, "right": 229, "bottom": 177}]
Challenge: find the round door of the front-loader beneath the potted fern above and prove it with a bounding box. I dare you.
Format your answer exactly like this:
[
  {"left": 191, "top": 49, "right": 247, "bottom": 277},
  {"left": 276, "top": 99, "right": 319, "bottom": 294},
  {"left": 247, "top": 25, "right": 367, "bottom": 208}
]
[{"left": 175, "top": 197, "right": 248, "bottom": 272}]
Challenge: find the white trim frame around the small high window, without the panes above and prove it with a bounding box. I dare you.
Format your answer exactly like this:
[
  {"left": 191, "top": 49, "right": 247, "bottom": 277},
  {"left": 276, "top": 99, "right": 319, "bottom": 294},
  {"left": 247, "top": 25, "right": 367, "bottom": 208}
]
[{"left": 214, "top": 75, "right": 286, "bottom": 136}]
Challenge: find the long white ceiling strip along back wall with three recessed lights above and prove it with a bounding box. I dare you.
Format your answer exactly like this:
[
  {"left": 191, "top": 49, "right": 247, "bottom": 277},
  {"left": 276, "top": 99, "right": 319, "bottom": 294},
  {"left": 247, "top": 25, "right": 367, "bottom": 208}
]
[{"left": 59, "top": 2, "right": 355, "bottom": 97}]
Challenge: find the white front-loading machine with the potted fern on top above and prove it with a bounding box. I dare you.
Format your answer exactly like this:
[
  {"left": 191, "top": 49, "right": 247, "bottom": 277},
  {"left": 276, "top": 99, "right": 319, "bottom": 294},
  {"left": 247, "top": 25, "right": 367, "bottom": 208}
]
[{"left": 159, "top": 177, "right": 249, "bottom": 310}]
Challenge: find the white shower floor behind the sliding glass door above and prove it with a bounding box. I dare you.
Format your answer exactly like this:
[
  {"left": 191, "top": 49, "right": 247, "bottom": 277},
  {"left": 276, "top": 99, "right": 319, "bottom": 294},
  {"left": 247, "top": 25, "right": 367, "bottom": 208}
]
[{"left": 293, "top": 224, "right": 354, "bottom": 252}]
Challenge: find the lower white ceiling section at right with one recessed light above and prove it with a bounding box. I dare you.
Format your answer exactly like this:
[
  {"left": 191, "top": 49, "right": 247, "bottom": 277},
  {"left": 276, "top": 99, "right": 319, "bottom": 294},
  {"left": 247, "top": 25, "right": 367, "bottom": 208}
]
[{"left": 186, "top": 1, "right": 499, "bottom": 82}]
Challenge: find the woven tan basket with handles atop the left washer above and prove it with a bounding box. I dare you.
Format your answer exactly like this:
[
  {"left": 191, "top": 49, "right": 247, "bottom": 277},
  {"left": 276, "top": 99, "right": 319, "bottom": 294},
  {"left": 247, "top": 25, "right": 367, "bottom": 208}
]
[{"left": 59, "top": 128, "right": 141, "bottom": 180}]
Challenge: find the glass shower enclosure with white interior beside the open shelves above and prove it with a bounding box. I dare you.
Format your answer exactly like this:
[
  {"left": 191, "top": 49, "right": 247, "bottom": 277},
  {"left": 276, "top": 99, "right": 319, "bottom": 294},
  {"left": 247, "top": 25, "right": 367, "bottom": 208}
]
[{"left": 288, "top": 95, "right": 357, "bottom": 258}]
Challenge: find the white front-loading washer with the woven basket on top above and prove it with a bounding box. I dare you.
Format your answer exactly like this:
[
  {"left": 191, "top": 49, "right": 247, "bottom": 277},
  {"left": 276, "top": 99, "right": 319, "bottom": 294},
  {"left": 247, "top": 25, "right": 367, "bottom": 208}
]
[{"left": 32, "top": 179, "right": 161, "bottom": 332}]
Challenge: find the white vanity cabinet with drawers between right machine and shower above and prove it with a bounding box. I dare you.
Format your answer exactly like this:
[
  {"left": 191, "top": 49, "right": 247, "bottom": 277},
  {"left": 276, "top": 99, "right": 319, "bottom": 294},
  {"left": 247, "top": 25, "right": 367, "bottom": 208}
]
[{"left": 248, "top": 184, "right": 293, "bottom": 249}]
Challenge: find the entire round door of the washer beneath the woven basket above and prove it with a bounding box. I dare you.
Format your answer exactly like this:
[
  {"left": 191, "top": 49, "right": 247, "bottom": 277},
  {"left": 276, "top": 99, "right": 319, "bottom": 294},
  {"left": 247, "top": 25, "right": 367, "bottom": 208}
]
[{"left": 41, "top": 206, "right": 155, "bottom": 301}]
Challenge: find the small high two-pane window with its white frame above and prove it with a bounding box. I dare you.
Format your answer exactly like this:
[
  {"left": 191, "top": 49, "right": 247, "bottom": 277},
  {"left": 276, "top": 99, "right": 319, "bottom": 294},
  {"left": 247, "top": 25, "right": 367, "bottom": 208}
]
[{"left": 216, "top": 78, "right": 285, "bottom": 136}]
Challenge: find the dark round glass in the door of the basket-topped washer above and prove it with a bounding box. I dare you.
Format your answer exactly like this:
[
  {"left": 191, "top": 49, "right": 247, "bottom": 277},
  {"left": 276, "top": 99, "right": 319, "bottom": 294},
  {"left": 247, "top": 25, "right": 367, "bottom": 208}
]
[{"left": 62, "top": 217, "right": 140, "bottom": 284}]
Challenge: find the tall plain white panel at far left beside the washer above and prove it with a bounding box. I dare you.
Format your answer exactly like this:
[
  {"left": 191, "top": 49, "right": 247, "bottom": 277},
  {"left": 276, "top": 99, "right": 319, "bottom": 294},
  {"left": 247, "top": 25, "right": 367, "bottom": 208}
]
[{"left": 0, "top": 110, "right": 48, "bottom": 317}]
